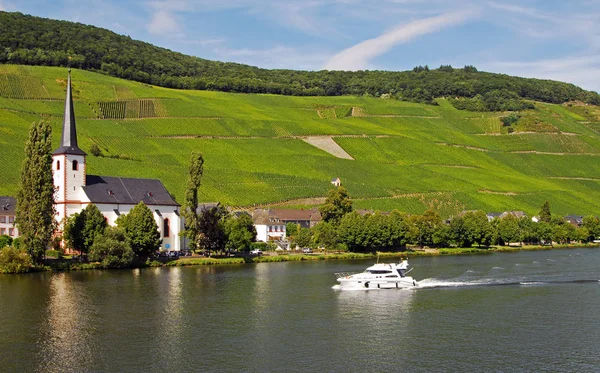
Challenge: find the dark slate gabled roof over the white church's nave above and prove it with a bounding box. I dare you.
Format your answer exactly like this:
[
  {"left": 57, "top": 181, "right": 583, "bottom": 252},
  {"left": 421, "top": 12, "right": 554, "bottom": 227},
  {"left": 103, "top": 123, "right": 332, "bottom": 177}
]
[{"left": 83, "top": 175, "right": 179, "bottom": 206}]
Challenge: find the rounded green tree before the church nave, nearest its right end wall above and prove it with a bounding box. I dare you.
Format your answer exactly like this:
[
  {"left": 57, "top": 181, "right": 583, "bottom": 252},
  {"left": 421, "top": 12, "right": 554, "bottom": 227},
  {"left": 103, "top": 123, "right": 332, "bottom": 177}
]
[{"left": 117, "top": 202, "right": 162, "bottom": 260}]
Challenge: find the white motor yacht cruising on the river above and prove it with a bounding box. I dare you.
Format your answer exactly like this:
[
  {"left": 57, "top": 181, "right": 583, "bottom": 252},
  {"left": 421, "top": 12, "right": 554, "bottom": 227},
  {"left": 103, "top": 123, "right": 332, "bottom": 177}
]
[{"left": 335, "top": 259, "right": 418, "bottom": 290}]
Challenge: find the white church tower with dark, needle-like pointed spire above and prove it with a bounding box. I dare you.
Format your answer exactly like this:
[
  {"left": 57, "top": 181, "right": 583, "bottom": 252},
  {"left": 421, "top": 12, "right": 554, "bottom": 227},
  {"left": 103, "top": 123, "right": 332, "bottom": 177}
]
[{"left": 52, "top": 69, "right": 86, "bottom": 222}]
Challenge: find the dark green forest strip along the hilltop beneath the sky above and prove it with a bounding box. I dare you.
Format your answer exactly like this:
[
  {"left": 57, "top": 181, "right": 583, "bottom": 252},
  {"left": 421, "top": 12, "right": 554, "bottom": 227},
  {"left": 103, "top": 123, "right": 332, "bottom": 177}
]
[{"left": 0, "top": 12, "right": 600, "bottom": 107}]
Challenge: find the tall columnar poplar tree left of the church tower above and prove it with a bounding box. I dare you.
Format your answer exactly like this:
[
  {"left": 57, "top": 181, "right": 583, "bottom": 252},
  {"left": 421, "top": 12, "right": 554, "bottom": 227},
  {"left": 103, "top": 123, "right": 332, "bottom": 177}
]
[{"left": 15, "top": 121, "right": 56, "bottom": 263}]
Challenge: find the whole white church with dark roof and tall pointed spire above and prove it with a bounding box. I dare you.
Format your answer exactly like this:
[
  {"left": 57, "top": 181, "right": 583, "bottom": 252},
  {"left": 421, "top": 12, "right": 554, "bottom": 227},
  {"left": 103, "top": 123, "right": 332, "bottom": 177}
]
[{"left": 52, "top": 70, "right": 184, "bottom": 251}]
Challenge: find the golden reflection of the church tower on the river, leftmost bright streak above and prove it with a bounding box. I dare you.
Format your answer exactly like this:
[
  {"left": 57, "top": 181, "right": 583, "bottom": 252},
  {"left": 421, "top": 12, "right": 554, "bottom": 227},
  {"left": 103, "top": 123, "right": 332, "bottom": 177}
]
[{"left": 37, "top": 273, "right": 95, "bottom": 372}]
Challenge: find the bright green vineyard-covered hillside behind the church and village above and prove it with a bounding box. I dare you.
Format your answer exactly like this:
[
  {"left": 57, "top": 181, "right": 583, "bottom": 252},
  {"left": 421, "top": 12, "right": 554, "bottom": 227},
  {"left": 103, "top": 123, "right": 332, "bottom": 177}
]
[{"left": 0, "top": 65, "right": 600, "bottom": 215}]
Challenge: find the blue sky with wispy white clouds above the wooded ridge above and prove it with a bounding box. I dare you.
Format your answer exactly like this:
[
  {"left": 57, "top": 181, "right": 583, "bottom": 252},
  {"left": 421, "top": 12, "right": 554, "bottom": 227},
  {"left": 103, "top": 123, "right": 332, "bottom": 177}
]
[{"left": 0, "top": 0, "right": 600, "bottom": 92}]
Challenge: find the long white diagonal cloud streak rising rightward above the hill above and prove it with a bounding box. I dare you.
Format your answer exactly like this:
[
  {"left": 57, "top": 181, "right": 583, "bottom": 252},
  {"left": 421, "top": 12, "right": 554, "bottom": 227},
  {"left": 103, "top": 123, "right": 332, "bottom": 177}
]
[{"left": 323, "top": 11, "right": 476, "bottom": 70}]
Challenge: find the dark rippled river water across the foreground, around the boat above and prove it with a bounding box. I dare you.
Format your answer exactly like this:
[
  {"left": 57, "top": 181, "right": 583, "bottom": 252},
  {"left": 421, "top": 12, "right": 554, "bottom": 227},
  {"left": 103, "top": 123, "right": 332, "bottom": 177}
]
[{"left": 0, "top": 249, "right": 600, "bottom": 372}]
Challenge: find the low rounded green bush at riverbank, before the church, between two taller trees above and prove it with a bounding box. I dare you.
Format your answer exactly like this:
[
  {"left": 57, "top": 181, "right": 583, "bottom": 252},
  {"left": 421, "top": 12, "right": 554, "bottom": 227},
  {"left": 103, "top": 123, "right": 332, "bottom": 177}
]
[{"left": 89, "top": 227, "right": 134, "bottom": 268}]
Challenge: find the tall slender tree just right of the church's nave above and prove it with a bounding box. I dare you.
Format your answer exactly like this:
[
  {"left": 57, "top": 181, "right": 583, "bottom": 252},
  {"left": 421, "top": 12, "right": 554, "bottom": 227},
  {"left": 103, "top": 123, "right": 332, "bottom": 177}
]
[{"left": 182, "top": 153, "right": 204, "bottom": 250}]
